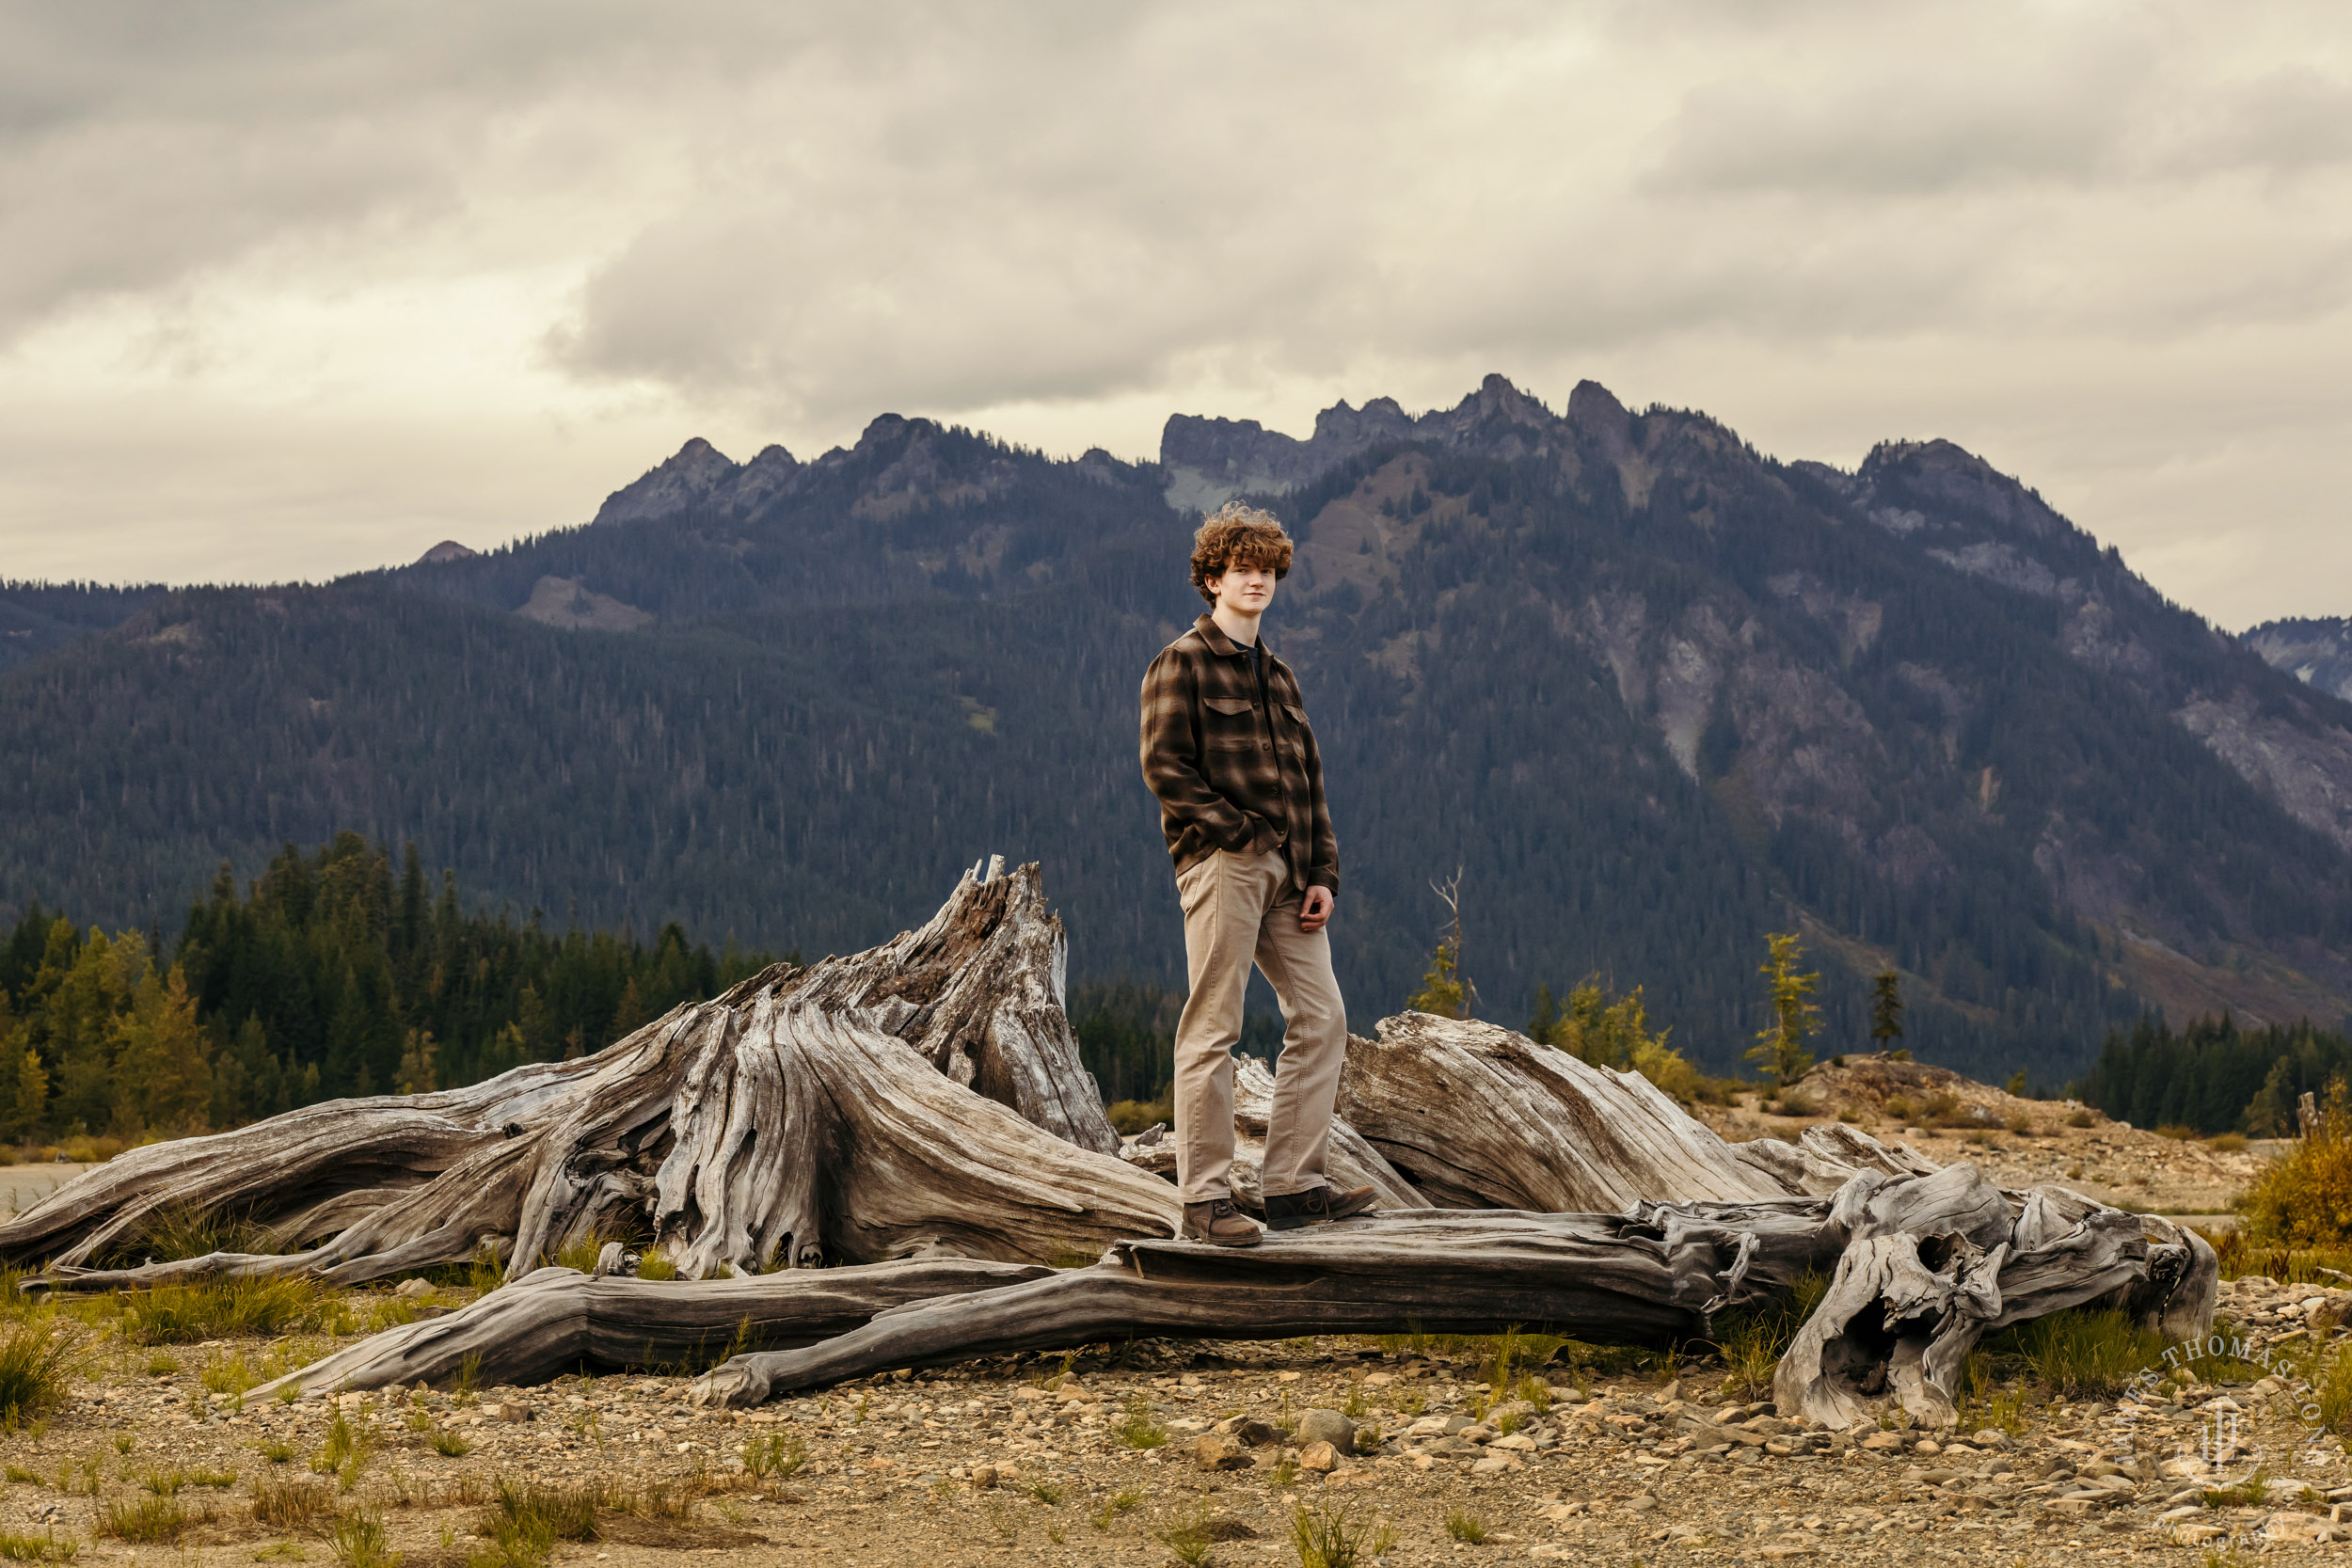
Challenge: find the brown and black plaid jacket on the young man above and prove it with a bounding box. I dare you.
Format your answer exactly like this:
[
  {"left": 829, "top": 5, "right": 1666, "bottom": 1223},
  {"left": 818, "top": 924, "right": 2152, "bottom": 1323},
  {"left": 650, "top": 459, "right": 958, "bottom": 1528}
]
[{"left": 1143, "top": 616, "right": 1339, "bottom": 894}]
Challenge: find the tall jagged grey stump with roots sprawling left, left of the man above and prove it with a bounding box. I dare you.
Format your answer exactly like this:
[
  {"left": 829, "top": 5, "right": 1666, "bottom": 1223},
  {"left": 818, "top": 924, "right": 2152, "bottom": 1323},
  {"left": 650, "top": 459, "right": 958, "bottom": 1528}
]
[{"left": 0, "top": 865, "right": 1174, "bottom": 1289}]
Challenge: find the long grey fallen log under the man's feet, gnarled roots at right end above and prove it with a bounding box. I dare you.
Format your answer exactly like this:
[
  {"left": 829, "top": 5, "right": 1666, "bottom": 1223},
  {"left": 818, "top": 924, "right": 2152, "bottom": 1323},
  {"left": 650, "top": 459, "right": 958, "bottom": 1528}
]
[{"left": 673, "top": 1164, "right": 2218, "bottom": 1427}]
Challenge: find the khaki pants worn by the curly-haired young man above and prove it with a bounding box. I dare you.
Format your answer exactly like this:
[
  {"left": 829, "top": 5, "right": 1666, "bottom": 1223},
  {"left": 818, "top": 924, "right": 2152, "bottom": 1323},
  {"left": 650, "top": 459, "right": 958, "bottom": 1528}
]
[{"left": 1176, "top": 848, "right": 1348, "bottom": 1204}]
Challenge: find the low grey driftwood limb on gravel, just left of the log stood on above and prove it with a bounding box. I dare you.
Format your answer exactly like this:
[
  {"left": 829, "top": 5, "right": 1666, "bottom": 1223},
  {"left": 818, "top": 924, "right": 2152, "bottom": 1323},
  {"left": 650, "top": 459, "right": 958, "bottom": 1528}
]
[{"left": 249, "top": 1243, "right": 1052, "bottom": 1399}]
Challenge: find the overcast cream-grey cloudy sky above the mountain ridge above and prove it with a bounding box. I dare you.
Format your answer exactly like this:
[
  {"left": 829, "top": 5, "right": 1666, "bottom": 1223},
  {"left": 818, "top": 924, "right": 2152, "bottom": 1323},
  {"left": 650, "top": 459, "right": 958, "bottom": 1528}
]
[{"left": 0, "top": 0, "right": 2352, "bottom": 627}]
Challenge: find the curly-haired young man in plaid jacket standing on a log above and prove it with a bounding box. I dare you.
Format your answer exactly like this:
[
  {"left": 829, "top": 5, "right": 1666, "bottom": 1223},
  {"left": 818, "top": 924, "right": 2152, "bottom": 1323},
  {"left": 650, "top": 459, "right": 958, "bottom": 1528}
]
[{"left": 1143, "top": 505, "right": 1372, "bottom": 1246}]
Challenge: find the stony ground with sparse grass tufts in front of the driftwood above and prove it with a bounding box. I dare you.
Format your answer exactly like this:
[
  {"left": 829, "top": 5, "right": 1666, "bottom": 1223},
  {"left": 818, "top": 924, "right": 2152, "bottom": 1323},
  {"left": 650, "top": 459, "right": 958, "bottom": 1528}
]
[{"left": 13, "top": 1279, "right": 2352, "bottom": 1568}]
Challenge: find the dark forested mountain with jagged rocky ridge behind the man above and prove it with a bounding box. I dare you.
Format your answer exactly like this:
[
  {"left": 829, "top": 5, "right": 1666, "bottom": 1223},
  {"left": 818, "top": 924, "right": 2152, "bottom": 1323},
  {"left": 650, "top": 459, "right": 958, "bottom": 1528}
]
[{"left": 0, "top": 378, "right": 2352, "bottom": 1082}]
